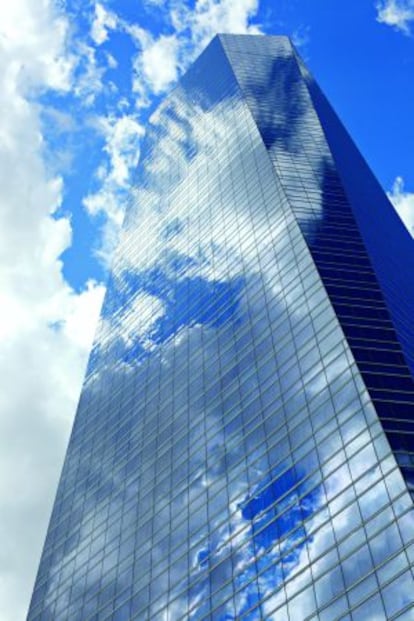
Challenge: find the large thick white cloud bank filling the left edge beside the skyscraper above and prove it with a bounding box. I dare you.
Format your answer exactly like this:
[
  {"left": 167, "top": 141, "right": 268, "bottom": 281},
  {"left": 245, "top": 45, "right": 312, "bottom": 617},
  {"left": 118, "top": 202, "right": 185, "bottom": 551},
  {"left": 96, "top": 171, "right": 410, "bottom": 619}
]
[{"left": 0, "top": 0, "right": 103, "bottom": 621}]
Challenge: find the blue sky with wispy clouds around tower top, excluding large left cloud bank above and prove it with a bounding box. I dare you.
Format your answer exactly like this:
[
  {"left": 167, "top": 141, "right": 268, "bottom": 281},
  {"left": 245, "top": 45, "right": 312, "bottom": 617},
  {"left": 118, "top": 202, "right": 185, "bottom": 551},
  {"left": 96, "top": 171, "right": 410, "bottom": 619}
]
[{"left": 41, "top": 0, "right": 414, "bottom": 291}]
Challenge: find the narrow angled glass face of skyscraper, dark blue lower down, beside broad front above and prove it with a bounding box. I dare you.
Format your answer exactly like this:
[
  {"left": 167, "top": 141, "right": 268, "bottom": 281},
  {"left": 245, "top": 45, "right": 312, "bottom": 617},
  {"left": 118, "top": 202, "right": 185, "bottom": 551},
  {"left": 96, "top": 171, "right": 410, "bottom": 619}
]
[{"left": 223, "top": 37, "right": 414, "bottom": 496}]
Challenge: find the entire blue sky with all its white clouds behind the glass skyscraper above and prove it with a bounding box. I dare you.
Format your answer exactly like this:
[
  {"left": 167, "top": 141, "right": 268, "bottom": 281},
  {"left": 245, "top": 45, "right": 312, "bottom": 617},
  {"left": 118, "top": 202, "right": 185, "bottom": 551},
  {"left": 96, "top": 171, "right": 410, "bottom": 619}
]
[{"left": 0, "top": 0, "right": 414, "bottom": 621}]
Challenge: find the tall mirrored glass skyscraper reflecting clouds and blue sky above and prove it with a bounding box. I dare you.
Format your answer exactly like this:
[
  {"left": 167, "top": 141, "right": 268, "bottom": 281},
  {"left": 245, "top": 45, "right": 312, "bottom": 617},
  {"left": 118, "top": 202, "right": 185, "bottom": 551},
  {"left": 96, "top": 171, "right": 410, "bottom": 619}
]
[{"left": 28, "top": 35, "right": 414, "bottom": 621}]
